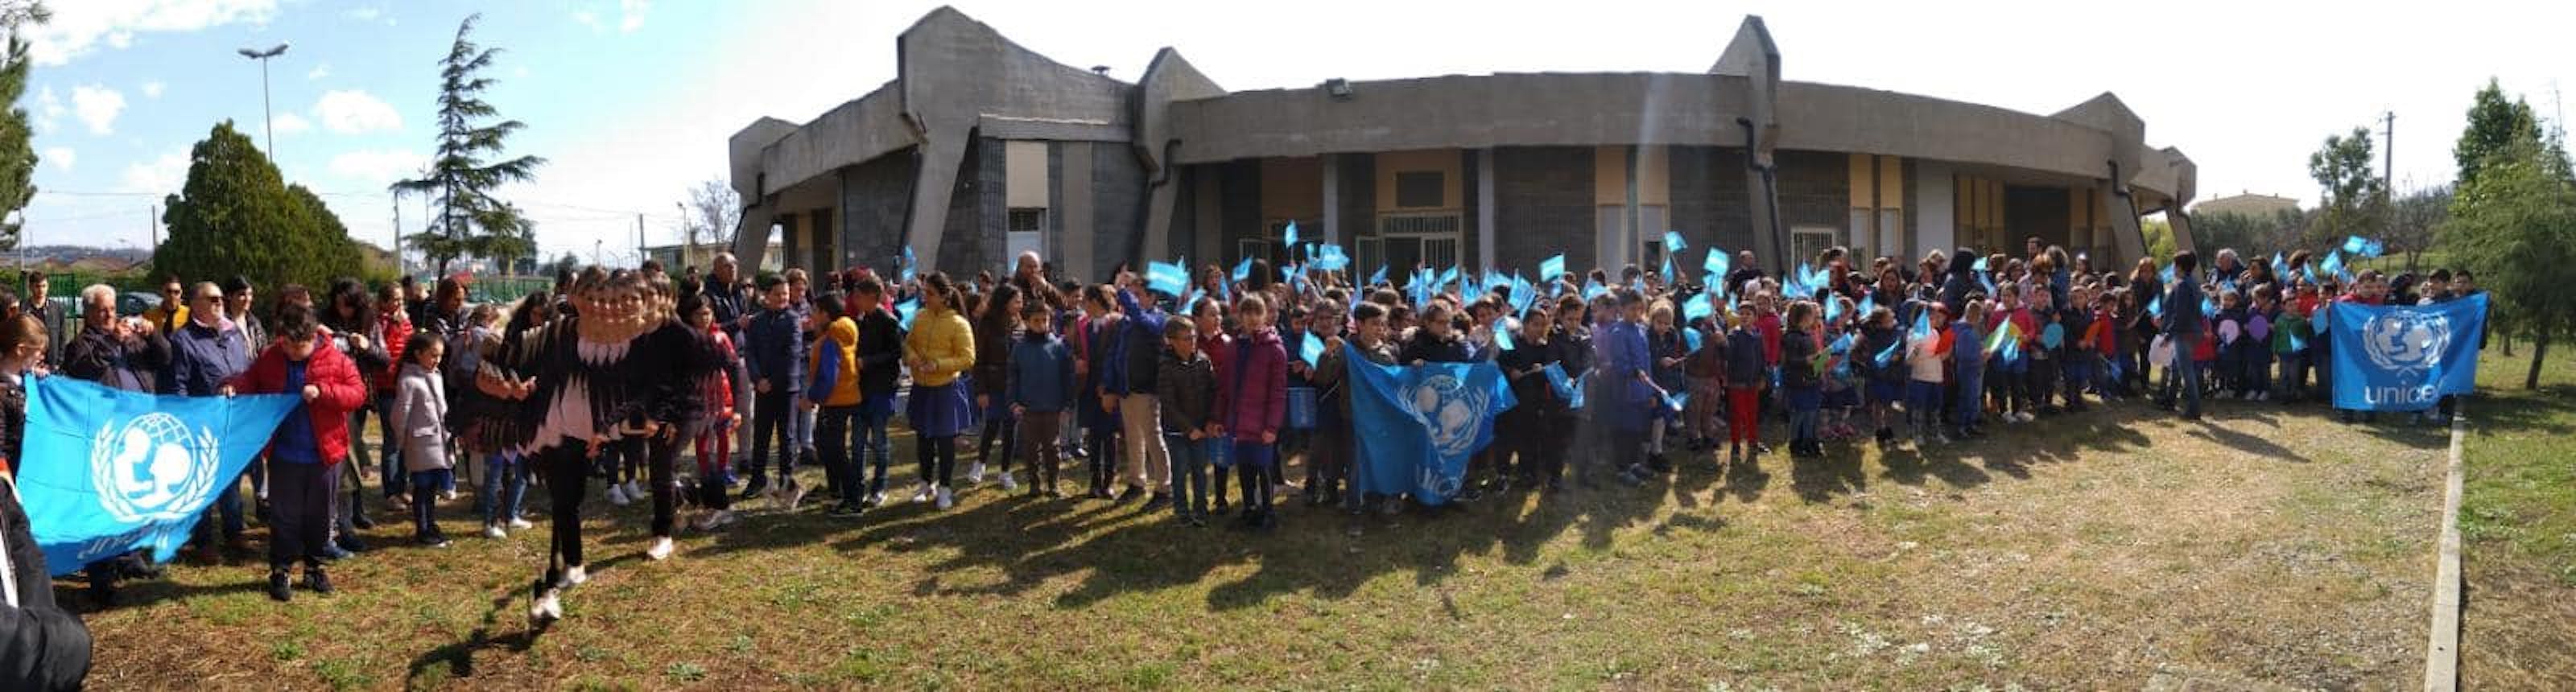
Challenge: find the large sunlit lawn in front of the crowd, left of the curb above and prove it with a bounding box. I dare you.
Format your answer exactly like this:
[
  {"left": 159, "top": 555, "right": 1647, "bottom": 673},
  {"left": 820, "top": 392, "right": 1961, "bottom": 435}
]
[{"left": 60, "top": 368, "right": 2493, "bottom": 690}]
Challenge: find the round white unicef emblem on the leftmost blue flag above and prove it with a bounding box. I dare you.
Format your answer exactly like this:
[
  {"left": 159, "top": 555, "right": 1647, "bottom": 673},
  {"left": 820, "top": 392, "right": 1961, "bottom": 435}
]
[{"left": 90, "top": 412, "right": 219, "bottom": 522}]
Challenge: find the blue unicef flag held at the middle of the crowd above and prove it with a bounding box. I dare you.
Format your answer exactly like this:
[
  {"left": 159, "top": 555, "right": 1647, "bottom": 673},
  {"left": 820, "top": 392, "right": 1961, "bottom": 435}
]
[{"left": 1344, "top": 344, "right": 1517, "bottom": 505}]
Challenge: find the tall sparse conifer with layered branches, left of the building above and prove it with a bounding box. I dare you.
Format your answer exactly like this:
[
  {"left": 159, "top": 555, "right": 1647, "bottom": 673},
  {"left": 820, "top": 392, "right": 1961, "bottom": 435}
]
[{"left": 391, "top": 15, "right": 546, "bottom": 275}]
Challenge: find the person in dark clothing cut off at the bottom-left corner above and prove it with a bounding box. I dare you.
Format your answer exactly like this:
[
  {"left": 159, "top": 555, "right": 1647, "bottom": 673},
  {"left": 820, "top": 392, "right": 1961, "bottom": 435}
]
[{"left": 0, "top": 471, "right": 90, "bottom": 690}]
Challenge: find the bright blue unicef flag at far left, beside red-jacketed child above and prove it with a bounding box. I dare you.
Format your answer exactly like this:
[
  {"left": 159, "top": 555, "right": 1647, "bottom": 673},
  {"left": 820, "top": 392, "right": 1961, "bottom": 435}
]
[{"left": 18, "top": 378, "right": 296, "bottom": 576}]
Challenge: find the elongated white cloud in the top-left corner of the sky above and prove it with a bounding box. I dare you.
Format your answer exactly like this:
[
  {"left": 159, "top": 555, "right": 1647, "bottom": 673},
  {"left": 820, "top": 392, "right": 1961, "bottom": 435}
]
[{"left": 28, "top": 0, "right": 279, "bottom": 64}]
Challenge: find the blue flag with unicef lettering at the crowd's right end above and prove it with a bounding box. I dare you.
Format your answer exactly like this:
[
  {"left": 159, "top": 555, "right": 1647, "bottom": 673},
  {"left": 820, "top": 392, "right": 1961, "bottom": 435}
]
[{"left": 2329, "top": 293, "right": 2486, "bottom": 412}]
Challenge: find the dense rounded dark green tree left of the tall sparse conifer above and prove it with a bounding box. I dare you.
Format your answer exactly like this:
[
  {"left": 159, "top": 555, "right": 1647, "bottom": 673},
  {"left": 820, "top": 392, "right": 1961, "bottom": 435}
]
[{"left": 152, "top": 121, "right": 376, "bottom": 296}]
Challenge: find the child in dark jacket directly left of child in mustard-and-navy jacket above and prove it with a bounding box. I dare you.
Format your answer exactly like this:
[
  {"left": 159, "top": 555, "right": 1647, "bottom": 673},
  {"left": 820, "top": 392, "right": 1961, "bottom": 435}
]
[{"left": 741, "top": 274, "right": 803, "bottom": 499}]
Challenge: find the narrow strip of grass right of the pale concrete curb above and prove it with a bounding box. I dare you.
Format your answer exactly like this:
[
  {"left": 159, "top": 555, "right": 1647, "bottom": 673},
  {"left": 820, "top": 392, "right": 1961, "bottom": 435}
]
[{"left": 2460, "top": 348, "right": 2576, "bottom": 690}]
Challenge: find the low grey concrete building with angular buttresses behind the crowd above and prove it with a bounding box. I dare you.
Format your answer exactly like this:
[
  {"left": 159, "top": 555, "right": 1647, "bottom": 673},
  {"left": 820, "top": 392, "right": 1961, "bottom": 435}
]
[{"left": 729, "top": 8, "right": 2194, "bottom": 278}]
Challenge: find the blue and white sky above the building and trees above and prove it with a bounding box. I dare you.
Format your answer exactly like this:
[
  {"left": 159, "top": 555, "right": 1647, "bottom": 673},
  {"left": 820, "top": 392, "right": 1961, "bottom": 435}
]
[{"left": 21, "top": 0, "right": 2576, "bottom": 260}]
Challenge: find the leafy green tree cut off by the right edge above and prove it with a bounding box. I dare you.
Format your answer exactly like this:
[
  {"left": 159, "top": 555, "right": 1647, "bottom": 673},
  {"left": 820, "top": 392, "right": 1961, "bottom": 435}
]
[{"left": 2442, "top": 131, "right": 2576, "bottom": 389}]
